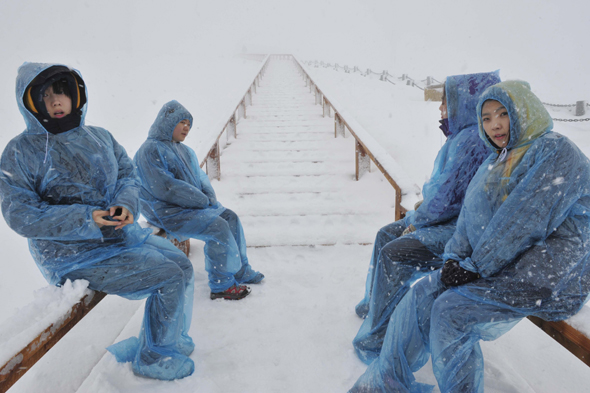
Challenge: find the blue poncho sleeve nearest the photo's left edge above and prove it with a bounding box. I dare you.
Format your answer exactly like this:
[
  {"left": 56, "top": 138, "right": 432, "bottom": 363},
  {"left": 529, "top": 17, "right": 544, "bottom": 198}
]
[{"left": 0, "top": 141, "right": 102, "bottom": 241}]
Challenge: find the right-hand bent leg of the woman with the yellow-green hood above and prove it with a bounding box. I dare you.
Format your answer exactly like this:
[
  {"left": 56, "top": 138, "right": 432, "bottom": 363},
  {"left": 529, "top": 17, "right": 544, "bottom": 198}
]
[{"left": 430, "top": 290, "right": 524, "bottom": 393}]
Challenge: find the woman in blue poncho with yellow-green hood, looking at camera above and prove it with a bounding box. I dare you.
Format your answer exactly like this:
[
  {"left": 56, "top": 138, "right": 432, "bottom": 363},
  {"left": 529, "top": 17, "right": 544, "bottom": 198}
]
[{"left": 351, "top": 81, "right": 590, "bottom": 393}]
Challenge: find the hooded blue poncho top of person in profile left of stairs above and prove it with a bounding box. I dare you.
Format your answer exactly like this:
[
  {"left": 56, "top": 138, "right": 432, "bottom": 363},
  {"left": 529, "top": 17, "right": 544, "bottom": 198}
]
[{"left": 134, "top": 101, "right": 225, "bottom": 240}]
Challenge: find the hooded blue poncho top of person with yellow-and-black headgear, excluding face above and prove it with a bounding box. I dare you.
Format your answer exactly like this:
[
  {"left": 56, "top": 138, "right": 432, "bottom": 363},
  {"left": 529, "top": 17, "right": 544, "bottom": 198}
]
[{"left": 0, "top": 63, "right": 150, "bottom": 284}]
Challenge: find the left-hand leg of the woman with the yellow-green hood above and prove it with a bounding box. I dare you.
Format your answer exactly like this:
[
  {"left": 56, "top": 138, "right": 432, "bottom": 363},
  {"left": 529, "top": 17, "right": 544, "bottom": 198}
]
[{"left": 350, "top": 271, "right": 446, "bottom": 393}]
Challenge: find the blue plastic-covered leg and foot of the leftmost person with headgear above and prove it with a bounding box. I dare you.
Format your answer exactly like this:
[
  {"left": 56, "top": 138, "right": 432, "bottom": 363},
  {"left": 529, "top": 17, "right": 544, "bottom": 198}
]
[{"left": 64, "top": 246, "right": 194, "bottom": 380}]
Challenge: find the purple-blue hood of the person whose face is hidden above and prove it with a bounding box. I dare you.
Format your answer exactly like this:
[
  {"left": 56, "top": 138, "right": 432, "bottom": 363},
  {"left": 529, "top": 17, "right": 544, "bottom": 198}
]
[{"left": 445, "top": 70, "right": 500, "bottom": 136}]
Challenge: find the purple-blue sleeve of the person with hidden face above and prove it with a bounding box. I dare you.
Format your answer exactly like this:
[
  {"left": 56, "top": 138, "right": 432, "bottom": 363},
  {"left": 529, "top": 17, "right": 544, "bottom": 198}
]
[{"left": 408, "top": 127, "right": 489, "bottom": 229}]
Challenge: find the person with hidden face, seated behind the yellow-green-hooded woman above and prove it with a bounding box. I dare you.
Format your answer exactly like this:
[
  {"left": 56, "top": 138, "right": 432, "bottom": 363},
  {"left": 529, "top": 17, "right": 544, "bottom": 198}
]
[{"left": 353, "top": 71, "right": 500, "bottom": 364}]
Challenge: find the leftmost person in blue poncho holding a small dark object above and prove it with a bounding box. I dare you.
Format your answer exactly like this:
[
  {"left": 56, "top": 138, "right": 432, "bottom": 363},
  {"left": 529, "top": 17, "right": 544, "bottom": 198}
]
[{"left": 0, "top": 63, "right": 199, "bottom": 380}]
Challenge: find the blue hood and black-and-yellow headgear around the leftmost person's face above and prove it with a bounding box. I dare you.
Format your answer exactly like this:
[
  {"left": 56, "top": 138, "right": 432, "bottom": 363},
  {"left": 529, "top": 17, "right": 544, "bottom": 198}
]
[{"left": 15, "top": 62, "right": 87, "bottom": 133}]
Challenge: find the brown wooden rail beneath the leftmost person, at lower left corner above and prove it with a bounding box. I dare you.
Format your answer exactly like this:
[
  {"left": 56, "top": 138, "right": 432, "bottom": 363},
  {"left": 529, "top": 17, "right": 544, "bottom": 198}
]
[{"left": 0, "top": 291, "right": 106, "bottom": 393}]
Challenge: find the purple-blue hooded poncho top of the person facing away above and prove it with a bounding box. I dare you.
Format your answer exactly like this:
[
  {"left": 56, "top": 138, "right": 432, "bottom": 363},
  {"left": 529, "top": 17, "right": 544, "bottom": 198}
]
[{"left": 405, "top": 71, "right": 500, "bottom": 254}]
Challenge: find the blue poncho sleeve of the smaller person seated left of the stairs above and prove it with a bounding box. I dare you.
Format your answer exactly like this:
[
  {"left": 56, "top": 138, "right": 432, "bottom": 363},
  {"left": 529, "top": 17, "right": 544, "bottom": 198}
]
[{"left": 136, "top": 142, "right": 211, "bottom": 209}]
